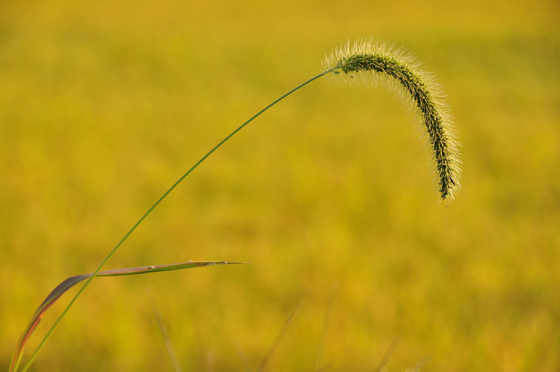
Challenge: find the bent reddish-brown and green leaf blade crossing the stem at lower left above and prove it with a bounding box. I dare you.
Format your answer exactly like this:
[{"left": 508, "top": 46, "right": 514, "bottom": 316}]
[{"left": 8, "top": 261, "right": 246, "bottom": 372}]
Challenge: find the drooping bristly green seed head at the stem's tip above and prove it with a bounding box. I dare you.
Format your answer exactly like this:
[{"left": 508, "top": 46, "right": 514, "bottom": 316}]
[{"left": 323, "top": 39, "right": 461, "bottom": 201}]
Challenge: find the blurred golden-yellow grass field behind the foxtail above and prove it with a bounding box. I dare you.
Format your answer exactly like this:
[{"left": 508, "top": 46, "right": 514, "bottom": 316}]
[{"left": 0, "top": 0, "right": 560, "bottom": 371}]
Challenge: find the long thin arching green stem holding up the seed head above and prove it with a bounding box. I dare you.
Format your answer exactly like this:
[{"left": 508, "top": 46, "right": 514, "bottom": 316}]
[{"left": 17, "top": 67, "right": 332, "bottom": 372}]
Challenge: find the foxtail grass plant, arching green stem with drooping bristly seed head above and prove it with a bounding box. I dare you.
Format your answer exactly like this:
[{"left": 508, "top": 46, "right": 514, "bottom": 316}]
[{"left": 10, "top": 39, "right": 461, "bottom": 372}]
